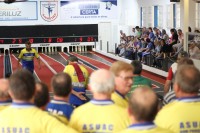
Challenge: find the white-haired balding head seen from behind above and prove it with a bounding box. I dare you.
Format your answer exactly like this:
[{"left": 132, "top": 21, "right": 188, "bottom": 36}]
[{"left": 89, "top": 69, "right": 115, "bottom": 94}]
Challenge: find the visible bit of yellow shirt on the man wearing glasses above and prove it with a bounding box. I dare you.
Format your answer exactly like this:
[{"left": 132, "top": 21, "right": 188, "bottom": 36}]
[{"left": 111, "top": 91, "right": 128, "bottom": 108}]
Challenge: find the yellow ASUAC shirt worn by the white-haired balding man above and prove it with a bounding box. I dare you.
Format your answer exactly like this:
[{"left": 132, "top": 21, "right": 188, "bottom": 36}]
[{"left": 69, "top": 100, "right": 130, "bottom": 133}]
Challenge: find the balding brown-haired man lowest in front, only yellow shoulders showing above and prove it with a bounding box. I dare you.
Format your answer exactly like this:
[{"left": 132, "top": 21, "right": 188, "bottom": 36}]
[{"left": 120, "top": 86, "right": 172, "bottom": 133}]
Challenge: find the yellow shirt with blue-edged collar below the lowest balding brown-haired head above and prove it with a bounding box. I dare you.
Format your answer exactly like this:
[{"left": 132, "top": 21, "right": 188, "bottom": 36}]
[{"left": 119, "top": 123, "right": 172, "bottom": 133}]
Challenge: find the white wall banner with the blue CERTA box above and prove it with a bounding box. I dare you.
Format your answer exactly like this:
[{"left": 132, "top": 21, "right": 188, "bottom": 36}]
[{"left": 60, "top": 0, "right": 118, "bottom": 20}]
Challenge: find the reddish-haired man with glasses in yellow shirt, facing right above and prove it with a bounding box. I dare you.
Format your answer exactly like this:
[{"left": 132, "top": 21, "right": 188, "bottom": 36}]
[{"left": 110, "top": 61, "right": 133, "bottom": 108}]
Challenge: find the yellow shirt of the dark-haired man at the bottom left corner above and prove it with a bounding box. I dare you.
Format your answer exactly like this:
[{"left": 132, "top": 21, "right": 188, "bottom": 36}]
[{"left": 0, "top": 103, "right": 77, "bottom": 133}]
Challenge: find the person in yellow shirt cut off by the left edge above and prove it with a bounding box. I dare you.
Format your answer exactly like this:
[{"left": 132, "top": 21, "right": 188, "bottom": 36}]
[{"left": 0, "top": 78, "right": 12, "bottom": 111}]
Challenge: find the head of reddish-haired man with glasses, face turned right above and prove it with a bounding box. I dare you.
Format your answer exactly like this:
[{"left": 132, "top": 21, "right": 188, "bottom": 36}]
[{"left": 110, "top": 61, "right": 133, "bottom": 95}]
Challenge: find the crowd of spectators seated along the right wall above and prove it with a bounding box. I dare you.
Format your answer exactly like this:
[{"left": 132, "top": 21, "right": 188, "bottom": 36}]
[{"left": 115, "top": 26, "right": 200, "bottom": 68}]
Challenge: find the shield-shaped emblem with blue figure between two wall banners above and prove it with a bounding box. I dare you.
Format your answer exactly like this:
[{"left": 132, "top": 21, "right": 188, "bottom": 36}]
[{"left": 40, "top": 1, "right": 58, "bottom": 22}]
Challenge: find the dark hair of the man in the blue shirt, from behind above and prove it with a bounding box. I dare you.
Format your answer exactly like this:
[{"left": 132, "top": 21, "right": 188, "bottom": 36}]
[{"left": 51, "top": 72, "right": 72, "bottom": 97}]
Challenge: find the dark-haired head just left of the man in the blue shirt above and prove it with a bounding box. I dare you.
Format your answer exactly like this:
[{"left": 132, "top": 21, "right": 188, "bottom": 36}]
[{"left": 34, "top": 82, "right": 49, "bottom": 107}]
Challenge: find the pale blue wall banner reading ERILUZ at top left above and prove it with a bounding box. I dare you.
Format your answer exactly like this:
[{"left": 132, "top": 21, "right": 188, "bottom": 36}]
[{"left": 0, "top": 1, "right": 38, "bottom": 21}]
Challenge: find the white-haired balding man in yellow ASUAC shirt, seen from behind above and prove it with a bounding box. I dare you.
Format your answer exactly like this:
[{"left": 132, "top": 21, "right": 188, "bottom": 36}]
[{"left": 69, "top": 69, "right": 130, "bottom": 133}]
